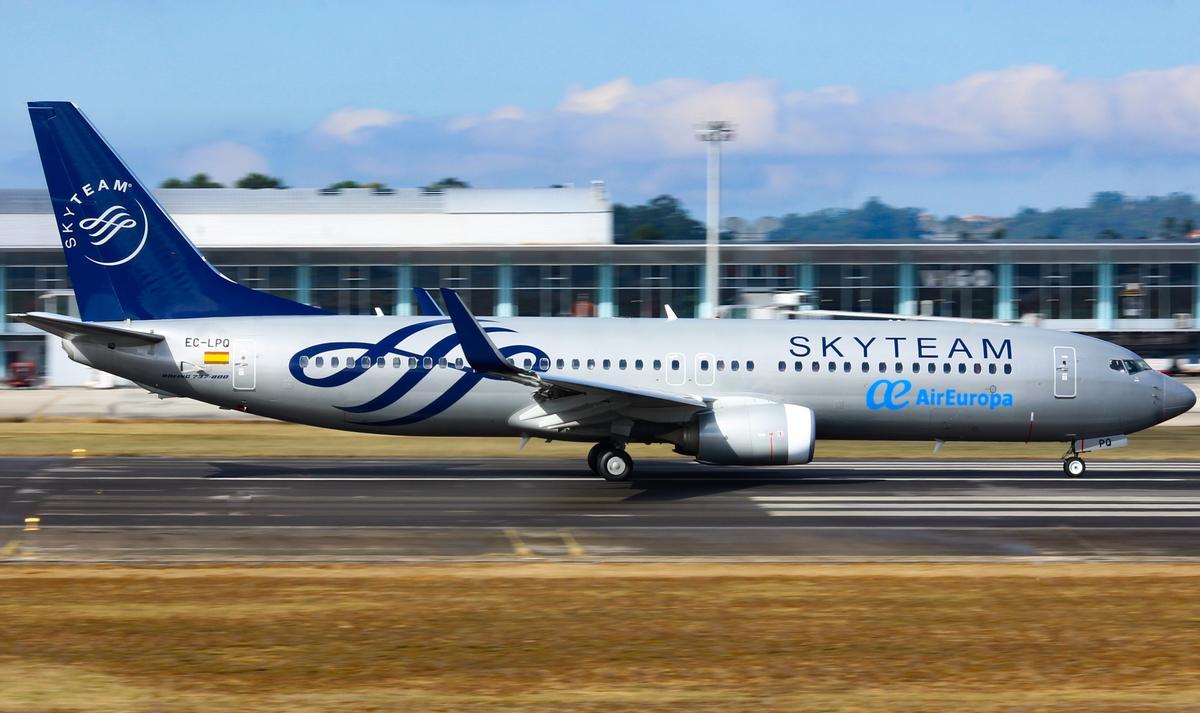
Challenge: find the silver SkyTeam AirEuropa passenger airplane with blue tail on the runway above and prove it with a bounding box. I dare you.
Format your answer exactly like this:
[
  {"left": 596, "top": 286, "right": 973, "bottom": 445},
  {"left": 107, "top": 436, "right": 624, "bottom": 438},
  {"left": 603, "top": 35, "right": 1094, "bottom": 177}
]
[{"left": 12, "top": 102, "right": 1195, "bottom": 480}]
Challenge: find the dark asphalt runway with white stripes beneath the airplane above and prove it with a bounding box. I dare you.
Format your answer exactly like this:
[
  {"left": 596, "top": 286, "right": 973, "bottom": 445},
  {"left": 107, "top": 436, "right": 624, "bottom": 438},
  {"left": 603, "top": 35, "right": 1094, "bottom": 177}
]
[{"left": 0, "top": 459, "right": 1200, "bottom": 564}]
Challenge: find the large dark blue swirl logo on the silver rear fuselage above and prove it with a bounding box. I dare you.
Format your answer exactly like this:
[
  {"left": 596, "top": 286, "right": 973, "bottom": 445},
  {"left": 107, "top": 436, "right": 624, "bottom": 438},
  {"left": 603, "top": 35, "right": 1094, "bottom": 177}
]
[{"left": 288, "top": 319, "right": 546, "bottom": 426}]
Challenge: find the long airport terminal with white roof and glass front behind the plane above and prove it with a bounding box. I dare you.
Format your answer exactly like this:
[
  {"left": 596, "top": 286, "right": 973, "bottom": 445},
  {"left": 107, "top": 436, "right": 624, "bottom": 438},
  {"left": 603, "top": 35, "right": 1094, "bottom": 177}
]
[{"left": 0, "top": 182, "right": 1200, "bottom": 384}]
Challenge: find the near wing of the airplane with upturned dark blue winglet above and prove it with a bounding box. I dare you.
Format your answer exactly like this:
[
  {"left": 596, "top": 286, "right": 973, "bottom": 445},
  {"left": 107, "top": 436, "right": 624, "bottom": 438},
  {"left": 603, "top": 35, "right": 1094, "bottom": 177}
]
[{"left": 442, "top": 287, "right": 709, "bottom": 415}]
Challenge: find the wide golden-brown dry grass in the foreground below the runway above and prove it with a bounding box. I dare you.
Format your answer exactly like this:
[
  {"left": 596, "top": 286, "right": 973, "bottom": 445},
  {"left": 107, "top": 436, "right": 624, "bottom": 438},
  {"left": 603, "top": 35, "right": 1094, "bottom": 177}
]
[{"left": 0, "top": 564, "right": 1200, "bottom": 713}]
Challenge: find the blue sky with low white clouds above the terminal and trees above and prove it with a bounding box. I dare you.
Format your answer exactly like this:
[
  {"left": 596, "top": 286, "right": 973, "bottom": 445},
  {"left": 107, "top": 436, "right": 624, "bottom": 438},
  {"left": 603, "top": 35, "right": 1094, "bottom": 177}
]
[{"left": 0, "top": 0, "right": 1200, "bottom": 217}]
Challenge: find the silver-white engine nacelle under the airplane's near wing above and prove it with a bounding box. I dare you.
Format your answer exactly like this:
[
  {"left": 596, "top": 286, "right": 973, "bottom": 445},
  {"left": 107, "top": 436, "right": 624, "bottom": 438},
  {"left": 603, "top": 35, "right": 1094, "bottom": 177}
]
[{"left": 676, "top": 403, "right": 816, "bottom": 466}]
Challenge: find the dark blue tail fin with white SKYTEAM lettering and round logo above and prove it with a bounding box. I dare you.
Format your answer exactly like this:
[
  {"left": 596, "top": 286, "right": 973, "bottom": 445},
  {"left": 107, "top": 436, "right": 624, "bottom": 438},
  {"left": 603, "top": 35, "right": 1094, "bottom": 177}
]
[{"left": 29, "top": 102, "right": 324, "bottom": 322}]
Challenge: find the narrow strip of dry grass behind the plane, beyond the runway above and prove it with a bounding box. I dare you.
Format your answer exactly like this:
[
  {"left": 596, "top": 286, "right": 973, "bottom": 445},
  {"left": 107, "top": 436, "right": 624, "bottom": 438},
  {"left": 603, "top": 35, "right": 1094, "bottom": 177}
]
[{"left": 0, "top": 420, "right": 1200, "bottom": 460}]
